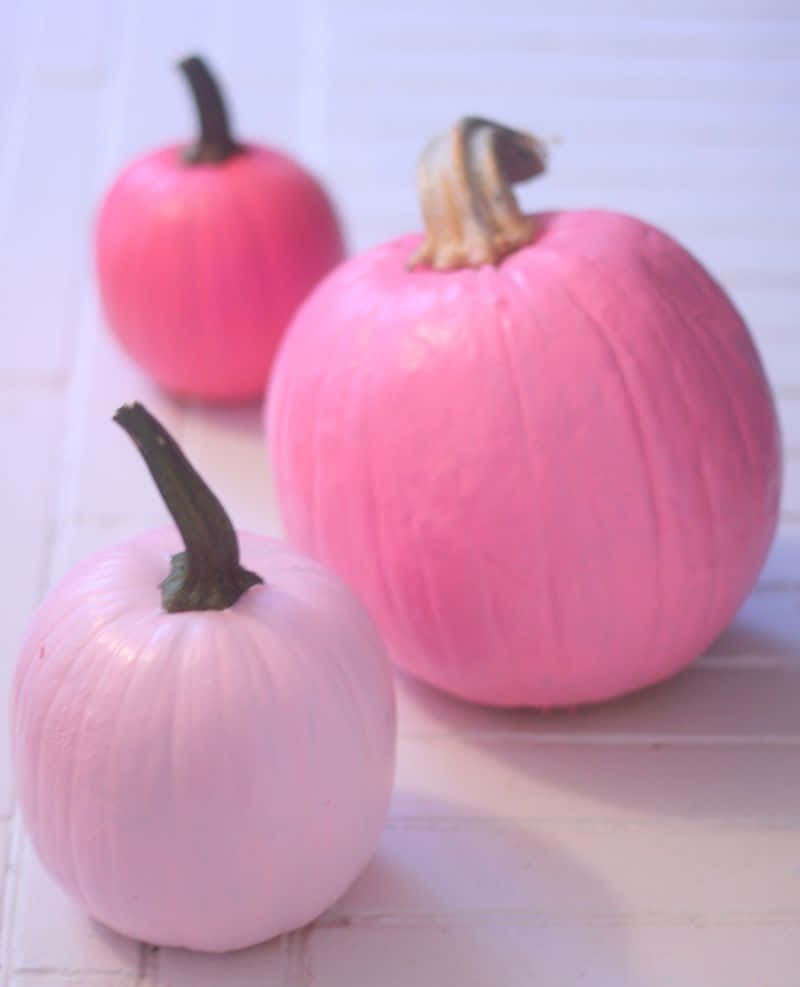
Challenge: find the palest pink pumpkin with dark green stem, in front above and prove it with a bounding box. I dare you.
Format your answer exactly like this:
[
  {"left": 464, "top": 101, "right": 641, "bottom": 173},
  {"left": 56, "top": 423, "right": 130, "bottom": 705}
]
[{"left": 6, "top": 405, "right": 395, "bottom": 951}]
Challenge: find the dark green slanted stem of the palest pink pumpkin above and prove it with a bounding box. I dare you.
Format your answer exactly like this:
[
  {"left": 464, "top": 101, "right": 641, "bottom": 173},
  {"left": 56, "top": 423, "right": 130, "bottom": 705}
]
[{"left": 114, "top": 402, "right": 264, "bottom": 613}]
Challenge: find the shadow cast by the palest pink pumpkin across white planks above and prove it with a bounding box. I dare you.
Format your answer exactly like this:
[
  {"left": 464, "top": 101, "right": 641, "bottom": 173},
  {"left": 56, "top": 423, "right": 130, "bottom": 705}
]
[{"left": 157, "top": 791, "right": 628, "bottom": 987}]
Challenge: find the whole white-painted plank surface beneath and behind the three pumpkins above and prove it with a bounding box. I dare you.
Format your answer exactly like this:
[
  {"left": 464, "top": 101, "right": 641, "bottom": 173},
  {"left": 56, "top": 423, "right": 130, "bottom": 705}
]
[{"left": 0, "top": 0, "right": 800, "bottom": 987}]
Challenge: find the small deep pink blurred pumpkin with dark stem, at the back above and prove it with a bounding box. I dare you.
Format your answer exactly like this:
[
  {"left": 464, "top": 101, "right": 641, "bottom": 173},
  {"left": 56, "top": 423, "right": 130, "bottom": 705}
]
[{"left": 95, "top": 57, "right": 344, "bottom": 402}]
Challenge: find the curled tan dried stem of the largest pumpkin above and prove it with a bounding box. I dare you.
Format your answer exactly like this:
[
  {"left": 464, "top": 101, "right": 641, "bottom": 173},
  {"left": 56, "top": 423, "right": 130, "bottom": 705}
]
[{"left": 408, "top": 117, "right": 546, "bottom": 270}]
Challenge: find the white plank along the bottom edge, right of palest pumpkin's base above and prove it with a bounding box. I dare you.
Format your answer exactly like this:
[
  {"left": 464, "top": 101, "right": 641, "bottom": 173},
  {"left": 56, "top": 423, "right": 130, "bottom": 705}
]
[{"left": 298, "top": 924, "right": 798, "bottom": 987}]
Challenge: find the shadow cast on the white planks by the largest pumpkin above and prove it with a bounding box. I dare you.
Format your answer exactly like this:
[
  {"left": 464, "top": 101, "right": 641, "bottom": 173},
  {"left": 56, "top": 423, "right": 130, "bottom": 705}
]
[{"left": 396, "top": 592, "right": 800, "bottom": 825}]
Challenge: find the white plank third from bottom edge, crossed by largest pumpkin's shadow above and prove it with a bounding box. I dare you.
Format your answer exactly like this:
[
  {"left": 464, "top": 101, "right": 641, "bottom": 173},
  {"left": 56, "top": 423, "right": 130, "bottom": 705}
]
[{"left": 392, "top": 733, "right": 800, "bottom": 829}]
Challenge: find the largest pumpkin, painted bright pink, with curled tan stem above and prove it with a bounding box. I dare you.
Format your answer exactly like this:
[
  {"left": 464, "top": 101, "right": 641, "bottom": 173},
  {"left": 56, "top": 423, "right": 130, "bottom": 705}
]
[{"left": 268, "top": 119, "right": 780, "bottom": 706}]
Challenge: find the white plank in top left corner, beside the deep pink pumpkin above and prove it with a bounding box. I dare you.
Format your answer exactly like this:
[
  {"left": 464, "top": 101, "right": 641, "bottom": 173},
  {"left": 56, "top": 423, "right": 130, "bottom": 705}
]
[{"left": 0, "top": 0, "right": 133, "bottom": 376}]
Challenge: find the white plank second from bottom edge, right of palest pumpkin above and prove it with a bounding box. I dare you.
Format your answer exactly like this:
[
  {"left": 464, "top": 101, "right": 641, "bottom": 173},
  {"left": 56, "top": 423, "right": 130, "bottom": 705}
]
[{"left": 322, "top": 820, "right": 800, "bottom": 929}]
